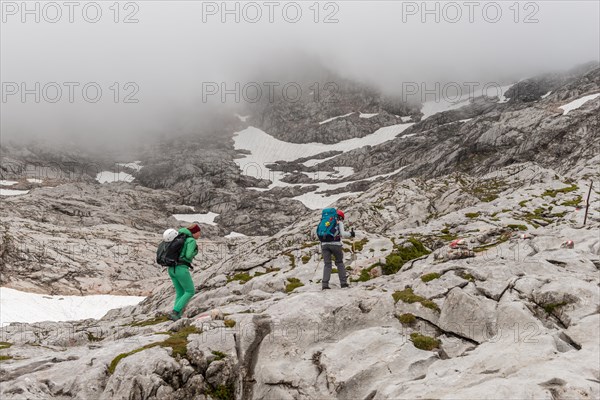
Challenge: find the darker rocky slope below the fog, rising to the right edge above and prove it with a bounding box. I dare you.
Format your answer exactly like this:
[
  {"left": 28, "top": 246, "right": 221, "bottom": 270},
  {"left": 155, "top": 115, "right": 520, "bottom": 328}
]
[{"left": 326, "top": 68, "right": 600, "bottom": 181}]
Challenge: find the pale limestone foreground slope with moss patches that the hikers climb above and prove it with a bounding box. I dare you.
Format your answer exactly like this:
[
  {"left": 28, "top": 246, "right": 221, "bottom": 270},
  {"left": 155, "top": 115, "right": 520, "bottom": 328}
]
[{"left": 0, "top": 158, "right": 600, "bottom": 399}]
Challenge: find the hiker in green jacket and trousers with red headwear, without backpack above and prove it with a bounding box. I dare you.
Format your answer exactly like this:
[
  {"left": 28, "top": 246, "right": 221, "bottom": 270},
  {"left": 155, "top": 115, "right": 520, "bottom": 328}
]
[{"left": 169, "top": 224, "right": 200, "bottom": 321}]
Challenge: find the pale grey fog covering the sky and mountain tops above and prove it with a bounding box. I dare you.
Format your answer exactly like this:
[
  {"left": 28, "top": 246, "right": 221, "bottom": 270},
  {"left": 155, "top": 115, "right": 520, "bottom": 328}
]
[{"left": 0, "top": 1, "right": 600, "bottom": 150}]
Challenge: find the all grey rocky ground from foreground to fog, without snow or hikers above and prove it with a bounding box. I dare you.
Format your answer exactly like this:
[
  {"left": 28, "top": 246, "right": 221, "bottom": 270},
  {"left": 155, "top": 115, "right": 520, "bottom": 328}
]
[{"left": 0, "top": 65, "right": 600, "bottom": 400}]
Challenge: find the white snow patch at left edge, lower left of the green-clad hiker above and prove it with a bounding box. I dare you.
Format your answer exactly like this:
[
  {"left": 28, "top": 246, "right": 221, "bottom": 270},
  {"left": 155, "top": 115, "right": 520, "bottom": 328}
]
[{"left": 0, "top": 287, "right": 145, "bottom": 326}]
